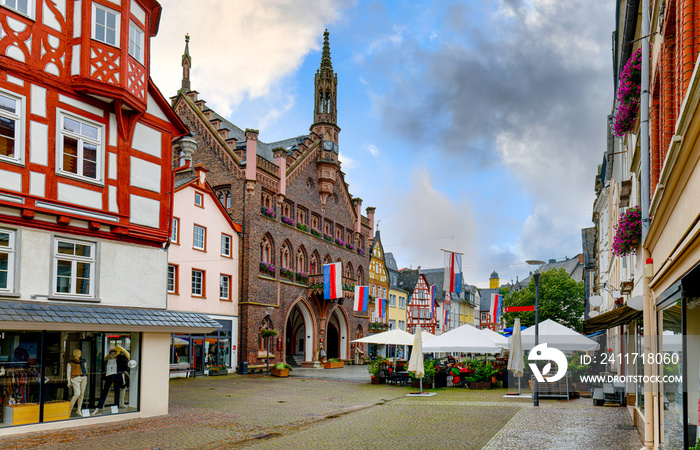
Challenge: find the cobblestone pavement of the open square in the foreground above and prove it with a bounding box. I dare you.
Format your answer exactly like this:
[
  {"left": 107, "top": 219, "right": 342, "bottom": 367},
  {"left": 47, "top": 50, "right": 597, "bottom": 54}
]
[{"left": 0, "top": 371, "right": 641, "bottom": 450}]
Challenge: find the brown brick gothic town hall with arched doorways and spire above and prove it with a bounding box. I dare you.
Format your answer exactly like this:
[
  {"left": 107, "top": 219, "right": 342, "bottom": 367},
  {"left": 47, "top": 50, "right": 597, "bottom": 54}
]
[{"left": 173, "top": 33, "right": 374, "bottom": 366}]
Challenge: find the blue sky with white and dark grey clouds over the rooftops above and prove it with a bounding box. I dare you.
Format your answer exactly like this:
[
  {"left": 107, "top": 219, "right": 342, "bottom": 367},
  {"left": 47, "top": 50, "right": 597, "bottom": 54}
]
[{"left": 151, "top": 0, "right": 615, "bottom": 287}]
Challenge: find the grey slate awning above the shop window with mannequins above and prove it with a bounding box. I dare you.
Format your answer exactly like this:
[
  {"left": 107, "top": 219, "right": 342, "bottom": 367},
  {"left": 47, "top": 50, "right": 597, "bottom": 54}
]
[{"left": 0, "top": 301, "right": 221, "bottom": 333}]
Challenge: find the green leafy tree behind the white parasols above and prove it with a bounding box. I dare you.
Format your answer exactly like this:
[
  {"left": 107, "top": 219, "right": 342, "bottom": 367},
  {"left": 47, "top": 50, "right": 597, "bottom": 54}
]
[{"left": 503, "top": 268, "right": 584, "bottom": 332}]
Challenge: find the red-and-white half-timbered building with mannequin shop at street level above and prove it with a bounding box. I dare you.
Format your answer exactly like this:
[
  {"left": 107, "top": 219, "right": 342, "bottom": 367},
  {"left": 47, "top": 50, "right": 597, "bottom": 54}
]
[{"left": 0, "top": 0, "right": 219, "bottom": 434}]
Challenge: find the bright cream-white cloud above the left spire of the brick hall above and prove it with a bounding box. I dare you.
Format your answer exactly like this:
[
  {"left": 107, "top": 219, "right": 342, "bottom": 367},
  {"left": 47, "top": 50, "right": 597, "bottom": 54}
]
[{"left": 151, "top": 0, "right": 348, "bottom": 116}]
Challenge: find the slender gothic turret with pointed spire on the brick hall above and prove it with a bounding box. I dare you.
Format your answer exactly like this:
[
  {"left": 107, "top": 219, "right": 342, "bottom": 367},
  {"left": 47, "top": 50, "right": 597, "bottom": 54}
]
[{"left": 311, "top": 30, "right": 340, "bottom": 210}]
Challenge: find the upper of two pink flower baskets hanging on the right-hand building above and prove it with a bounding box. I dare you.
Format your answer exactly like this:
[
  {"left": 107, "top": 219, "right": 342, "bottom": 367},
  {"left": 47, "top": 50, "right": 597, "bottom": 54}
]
[{"left": 613, "top": 48, "right": 642, "bottom": 137}]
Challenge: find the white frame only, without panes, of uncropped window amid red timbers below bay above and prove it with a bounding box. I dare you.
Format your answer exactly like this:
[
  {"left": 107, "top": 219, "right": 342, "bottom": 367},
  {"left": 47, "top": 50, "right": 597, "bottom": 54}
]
[{"left": 56, "top": 110, "right": 104, "bottom": 184}]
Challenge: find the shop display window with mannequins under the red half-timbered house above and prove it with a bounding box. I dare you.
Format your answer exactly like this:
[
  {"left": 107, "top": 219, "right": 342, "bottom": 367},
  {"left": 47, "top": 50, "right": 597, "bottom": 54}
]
[{"left": 0, "top": 331, "right": 140, "bottom": 426}]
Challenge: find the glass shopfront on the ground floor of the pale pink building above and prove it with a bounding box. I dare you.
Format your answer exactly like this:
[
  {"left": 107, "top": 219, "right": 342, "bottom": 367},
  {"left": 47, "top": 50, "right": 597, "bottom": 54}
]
[{"left": 170, "top": 319, "right": 232, "bottom": 372}]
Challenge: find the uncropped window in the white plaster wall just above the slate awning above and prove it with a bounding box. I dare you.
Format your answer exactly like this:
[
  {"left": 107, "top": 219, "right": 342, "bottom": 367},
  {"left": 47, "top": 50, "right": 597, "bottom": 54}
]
[{"left": 53, "top": 239, "right": 95, "bottom": 297}]
